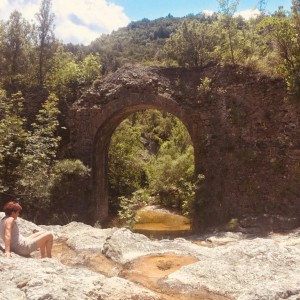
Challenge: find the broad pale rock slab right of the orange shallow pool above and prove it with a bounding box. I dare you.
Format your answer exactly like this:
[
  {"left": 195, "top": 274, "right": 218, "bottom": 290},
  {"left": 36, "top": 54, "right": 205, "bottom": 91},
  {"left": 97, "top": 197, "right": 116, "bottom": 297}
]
[{"left": 162, "top": 238, "right": 300, "bottom": 300}]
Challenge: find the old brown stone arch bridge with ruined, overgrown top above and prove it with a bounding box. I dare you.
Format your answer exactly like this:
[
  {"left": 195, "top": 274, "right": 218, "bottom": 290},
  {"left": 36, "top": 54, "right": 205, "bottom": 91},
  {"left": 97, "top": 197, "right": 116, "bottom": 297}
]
[{"left": 69, "top": 63, "right": 300, "bottom": 231}]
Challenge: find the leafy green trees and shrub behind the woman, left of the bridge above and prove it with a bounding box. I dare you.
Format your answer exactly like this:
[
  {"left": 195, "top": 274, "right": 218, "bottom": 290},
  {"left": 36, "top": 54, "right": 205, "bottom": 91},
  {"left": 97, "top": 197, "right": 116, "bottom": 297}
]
[{"left": 0, "top": 90, "right": 89, "bottom": 223}]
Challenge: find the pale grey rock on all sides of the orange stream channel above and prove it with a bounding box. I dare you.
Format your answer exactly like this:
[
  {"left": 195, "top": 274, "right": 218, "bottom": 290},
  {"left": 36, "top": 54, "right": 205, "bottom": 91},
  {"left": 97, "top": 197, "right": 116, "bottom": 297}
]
[{"left": 0, "top": 215, "right": 300, "bottom": 300}]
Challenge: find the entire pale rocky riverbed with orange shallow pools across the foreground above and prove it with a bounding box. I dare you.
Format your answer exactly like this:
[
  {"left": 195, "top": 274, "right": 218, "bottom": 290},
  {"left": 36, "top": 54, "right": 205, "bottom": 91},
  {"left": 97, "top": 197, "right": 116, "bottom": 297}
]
[{"left": 0, "top": 213, "right": 300, "bottom": 300}]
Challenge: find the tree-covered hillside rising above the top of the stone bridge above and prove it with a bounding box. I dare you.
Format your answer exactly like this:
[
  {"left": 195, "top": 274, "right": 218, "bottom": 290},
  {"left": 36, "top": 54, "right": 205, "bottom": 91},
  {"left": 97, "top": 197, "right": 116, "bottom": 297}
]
[{"left": 86, "top": 0, "right": 300, "bottom": 97}]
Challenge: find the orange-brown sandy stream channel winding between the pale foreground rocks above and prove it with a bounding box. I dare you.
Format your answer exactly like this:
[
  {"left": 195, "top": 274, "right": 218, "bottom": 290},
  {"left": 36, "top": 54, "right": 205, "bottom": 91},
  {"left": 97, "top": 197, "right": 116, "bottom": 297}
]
[{"left": 34, "top": 242, "right": 229, "bottom": 300}]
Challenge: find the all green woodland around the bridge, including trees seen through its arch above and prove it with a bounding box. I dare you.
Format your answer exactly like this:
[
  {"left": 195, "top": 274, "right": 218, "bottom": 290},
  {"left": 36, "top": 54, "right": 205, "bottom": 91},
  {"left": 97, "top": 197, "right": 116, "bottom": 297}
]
[{"left": 0, "top": 0, "right": 300, "bottom": 223}]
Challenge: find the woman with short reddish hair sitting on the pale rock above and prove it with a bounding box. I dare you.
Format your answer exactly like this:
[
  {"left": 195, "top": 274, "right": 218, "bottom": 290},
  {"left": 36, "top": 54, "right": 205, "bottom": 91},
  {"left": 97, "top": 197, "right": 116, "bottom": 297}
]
[{"left": 0, "top": 201, "right": 53, "bottom": 258}]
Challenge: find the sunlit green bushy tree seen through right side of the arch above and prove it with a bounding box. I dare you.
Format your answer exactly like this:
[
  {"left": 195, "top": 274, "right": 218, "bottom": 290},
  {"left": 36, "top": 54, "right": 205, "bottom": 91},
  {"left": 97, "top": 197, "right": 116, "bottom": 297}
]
[{"left": 147, "top": 119, "right": 194, "bottom": 209}]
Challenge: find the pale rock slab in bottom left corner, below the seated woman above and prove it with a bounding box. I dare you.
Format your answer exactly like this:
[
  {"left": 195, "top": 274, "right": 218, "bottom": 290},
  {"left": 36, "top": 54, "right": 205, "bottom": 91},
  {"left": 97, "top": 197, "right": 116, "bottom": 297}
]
[{"left": 0, "top": 257, "right": 159, "bottom": 300}]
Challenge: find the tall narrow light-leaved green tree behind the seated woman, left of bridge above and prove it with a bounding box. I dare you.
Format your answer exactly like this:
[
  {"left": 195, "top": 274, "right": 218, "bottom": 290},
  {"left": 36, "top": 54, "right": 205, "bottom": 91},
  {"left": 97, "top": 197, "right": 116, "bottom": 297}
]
[{"left": 18, "top": 95, "right": 60, "bottom": 213}]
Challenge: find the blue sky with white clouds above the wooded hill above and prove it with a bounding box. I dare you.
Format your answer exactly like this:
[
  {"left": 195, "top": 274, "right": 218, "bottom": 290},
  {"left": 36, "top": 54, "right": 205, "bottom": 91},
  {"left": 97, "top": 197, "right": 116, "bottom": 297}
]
[{"left": 0, "top": 0, "right": 292, "bottom": 45}]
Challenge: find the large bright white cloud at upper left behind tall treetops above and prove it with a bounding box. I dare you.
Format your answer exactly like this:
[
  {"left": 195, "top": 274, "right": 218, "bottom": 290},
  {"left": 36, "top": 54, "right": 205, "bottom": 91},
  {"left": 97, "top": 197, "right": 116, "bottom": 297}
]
[{"left": 0, "top": 0, "right": 130, "bottom": 45}]
